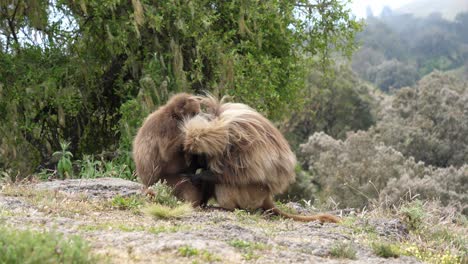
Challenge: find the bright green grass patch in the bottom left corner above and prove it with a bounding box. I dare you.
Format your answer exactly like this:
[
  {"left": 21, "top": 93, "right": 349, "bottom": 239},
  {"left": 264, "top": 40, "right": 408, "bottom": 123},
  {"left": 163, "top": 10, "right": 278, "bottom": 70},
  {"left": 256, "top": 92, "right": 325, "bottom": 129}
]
[{"left": 0, "top": 227, "right": 102, "bottom": 263}]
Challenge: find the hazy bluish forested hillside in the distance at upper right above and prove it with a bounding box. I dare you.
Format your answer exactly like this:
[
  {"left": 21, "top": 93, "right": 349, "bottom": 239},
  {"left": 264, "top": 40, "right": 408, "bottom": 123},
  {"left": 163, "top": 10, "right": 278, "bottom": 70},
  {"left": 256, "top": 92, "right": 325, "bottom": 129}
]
[{"left": 352, "top": 12, "right": 468, "bottom": 91}]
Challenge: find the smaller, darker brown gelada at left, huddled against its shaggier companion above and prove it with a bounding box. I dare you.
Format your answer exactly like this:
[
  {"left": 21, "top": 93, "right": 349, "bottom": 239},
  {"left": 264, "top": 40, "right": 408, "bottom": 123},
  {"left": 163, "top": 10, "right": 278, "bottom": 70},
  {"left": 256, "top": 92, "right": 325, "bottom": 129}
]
[{"left": 133, "top": 93, "right": 212, "bottom": 206}]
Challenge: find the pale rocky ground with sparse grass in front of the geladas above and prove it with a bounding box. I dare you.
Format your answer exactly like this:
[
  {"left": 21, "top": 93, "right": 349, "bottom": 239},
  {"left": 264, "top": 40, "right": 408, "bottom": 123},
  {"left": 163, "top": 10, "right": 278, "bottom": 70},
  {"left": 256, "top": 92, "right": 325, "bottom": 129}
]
[{"left": 0, "top": 178, "right": 419, "bottom": 263}]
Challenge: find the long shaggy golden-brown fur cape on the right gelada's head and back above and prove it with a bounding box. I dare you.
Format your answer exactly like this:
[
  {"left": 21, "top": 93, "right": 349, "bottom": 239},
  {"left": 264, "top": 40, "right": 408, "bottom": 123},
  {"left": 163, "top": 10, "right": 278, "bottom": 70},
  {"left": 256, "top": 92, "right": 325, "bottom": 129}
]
[{"left": 183, "top": 97, "right": 296, "bottom": 194}]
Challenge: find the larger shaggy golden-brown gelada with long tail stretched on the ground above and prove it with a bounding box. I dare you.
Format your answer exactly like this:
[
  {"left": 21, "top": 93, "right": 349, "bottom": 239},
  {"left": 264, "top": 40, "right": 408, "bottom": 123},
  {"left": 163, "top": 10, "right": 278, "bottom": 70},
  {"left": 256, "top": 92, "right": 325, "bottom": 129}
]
[{"left": 183, "top": 96, "right": 339, "bottom": 222}]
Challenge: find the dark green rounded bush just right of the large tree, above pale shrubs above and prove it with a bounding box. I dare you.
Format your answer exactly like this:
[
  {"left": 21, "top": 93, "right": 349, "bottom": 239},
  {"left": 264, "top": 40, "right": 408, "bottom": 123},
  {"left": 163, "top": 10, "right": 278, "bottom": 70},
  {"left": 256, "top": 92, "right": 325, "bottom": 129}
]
[{"left": 281, "top": 66, "right": 377, "bottom": 148}]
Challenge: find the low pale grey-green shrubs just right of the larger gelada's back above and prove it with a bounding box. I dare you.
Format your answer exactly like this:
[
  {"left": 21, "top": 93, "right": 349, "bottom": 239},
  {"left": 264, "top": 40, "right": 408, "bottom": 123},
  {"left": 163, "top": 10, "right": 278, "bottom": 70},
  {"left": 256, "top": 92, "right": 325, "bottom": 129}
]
[{"left": 300, "top": 131, "right": 468, "bottom": 214}]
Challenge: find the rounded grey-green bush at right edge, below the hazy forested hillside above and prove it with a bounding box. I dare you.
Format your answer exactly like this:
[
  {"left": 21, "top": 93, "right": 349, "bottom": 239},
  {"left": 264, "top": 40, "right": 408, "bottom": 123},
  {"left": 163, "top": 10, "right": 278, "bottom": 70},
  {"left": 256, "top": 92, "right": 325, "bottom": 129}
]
[{"left": 373, "top": 72, "right": 468, "bottom": 167}]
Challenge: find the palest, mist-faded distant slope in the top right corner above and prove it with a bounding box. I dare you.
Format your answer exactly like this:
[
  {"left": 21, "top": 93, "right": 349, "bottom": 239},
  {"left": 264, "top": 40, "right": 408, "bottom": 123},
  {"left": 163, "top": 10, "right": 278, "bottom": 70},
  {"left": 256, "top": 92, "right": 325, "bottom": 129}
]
[{"left": 395, "top": 0, "right": 468, "bottom": 19}]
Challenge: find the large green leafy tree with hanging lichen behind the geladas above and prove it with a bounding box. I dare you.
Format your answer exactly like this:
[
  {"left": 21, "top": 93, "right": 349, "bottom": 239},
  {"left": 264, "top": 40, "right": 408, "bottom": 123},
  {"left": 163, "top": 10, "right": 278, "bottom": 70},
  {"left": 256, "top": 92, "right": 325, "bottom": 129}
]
[{"left": 0, "top": 0, "right": 361, "bottom": 176}]
